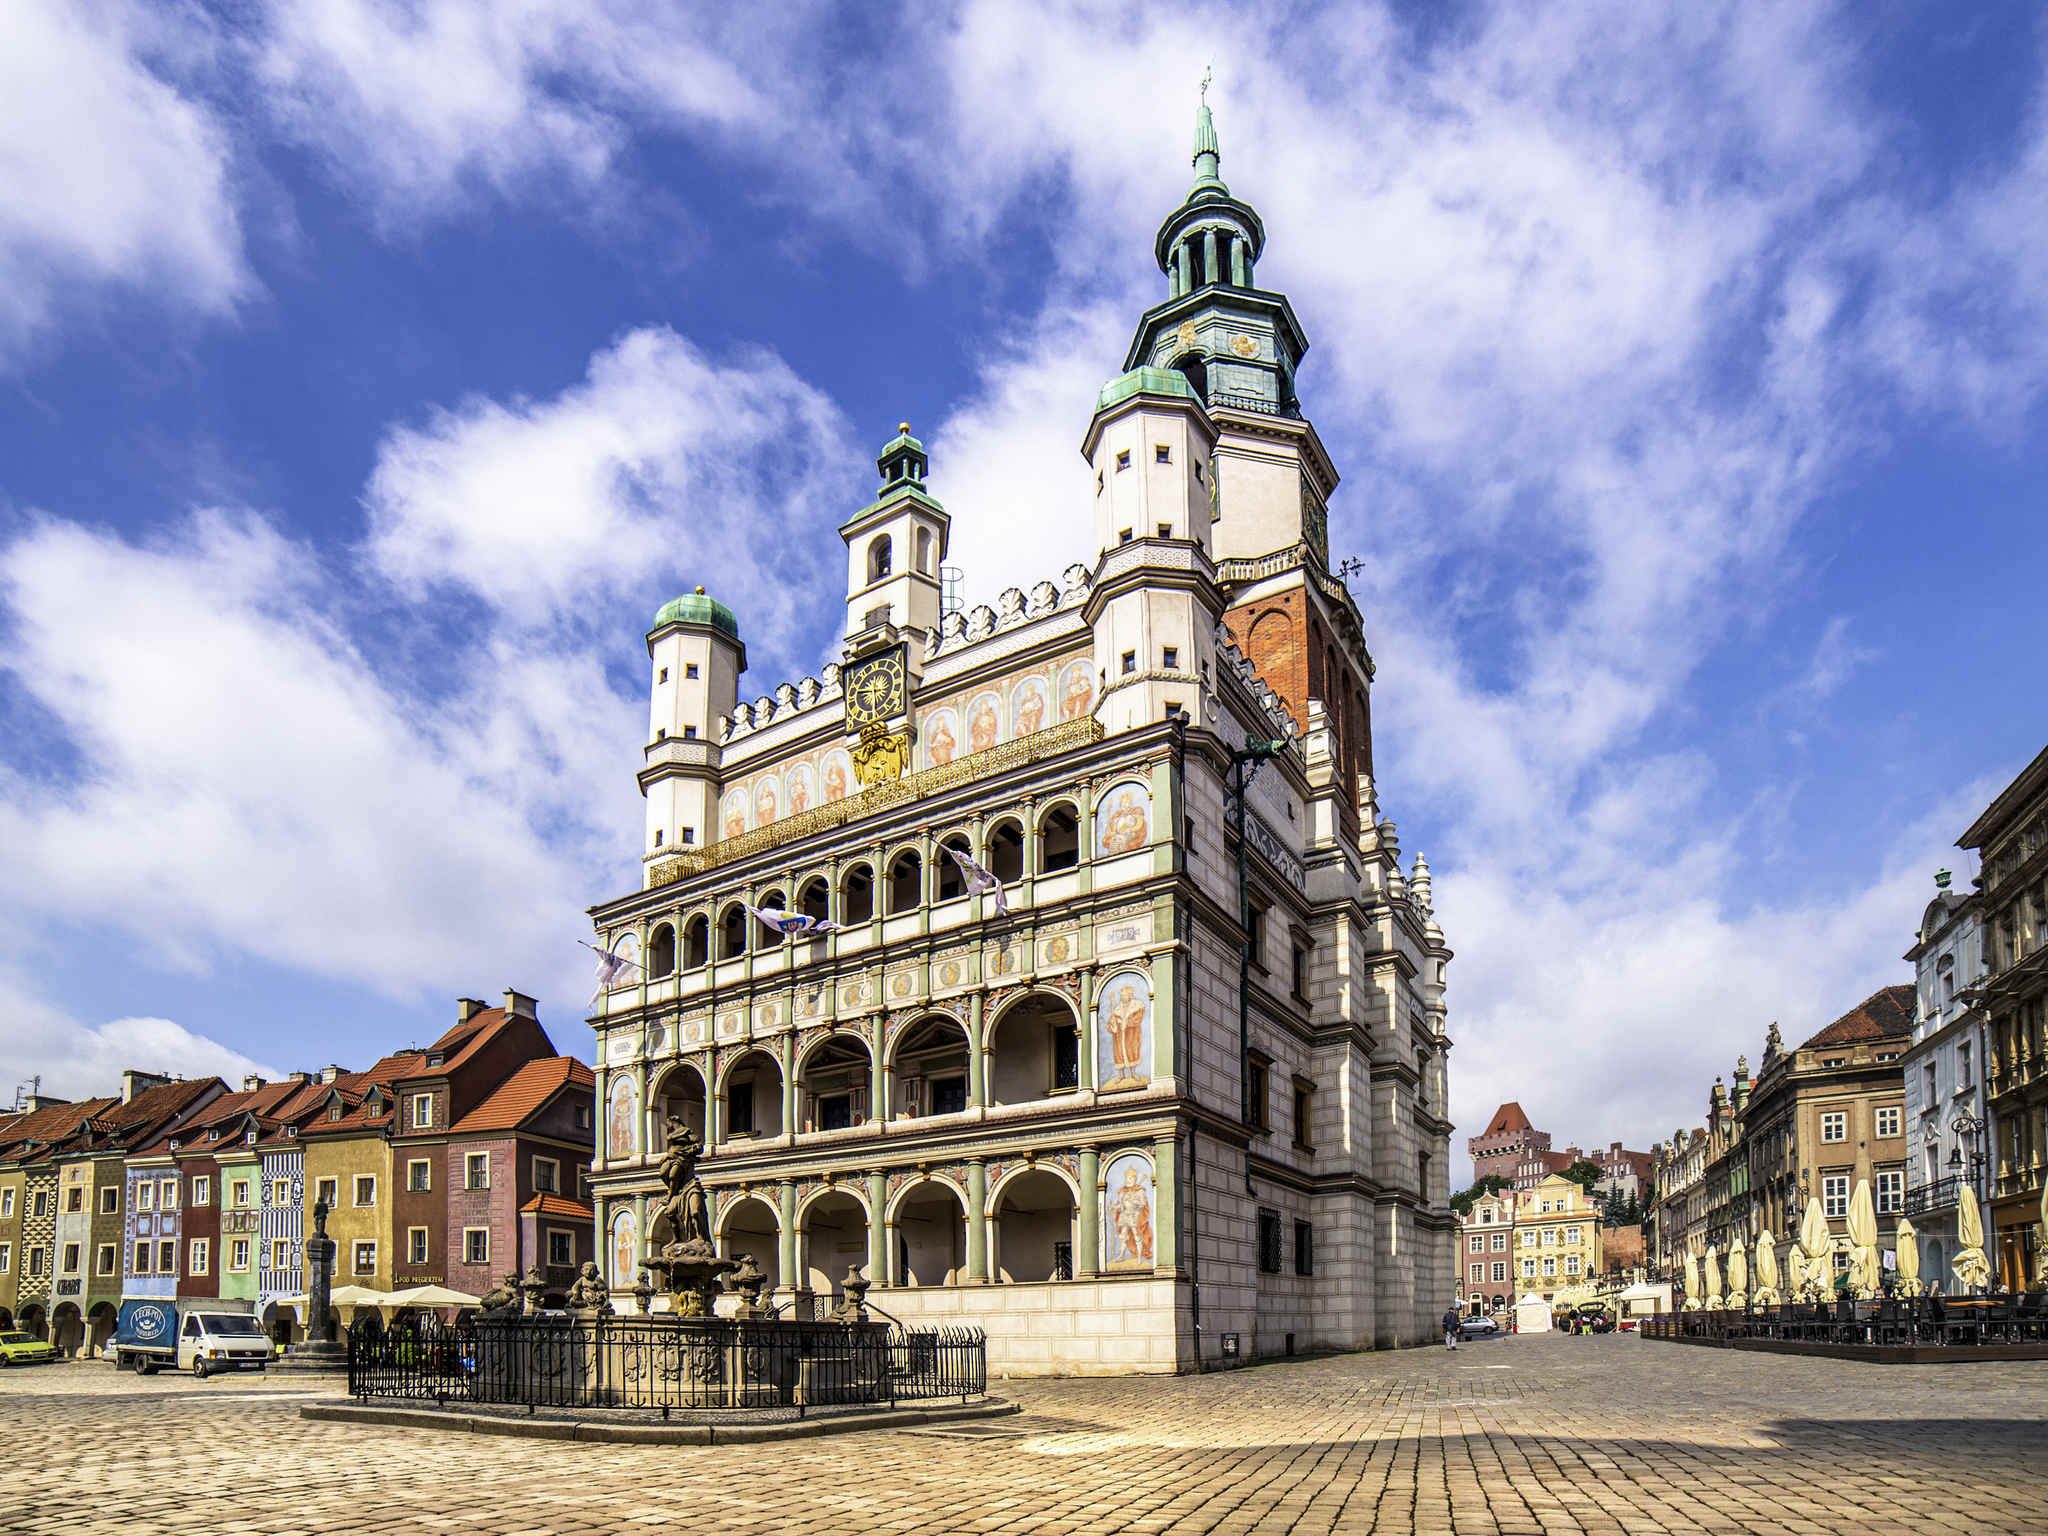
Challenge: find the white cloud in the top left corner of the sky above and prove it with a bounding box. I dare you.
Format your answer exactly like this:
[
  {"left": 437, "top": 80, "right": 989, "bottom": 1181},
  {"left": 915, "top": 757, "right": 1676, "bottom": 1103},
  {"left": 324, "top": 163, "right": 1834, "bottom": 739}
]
[{"left": 0, "top": 2, "right": 252, "bottom": 360}]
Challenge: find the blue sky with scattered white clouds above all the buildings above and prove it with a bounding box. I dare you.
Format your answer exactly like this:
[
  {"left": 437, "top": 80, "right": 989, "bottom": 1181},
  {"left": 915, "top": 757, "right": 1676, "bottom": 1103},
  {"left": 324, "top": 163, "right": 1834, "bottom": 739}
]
[{"left": 0, "top": 0, "right": 2048, "bottom": 1179}]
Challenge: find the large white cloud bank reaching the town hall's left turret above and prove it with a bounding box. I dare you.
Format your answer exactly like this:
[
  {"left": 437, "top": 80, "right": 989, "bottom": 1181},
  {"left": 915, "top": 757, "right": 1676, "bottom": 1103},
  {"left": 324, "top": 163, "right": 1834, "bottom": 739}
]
[{"left": 0, "top": 332, "right": 856, "bottom": 1073}]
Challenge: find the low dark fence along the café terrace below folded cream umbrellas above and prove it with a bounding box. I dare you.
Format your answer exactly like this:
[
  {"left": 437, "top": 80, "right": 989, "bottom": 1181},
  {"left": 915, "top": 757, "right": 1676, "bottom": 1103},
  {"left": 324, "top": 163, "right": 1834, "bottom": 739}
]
[{"left": 1640, "top": 1292, "right": 2048, "bottom": 1348}]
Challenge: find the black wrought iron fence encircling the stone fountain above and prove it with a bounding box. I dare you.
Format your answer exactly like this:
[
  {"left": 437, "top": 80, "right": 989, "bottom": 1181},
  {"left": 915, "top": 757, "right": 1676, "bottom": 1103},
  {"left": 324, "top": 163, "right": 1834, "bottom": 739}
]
[{"left": 348, "top": 1315, "right": 989, "bottom": 1417}]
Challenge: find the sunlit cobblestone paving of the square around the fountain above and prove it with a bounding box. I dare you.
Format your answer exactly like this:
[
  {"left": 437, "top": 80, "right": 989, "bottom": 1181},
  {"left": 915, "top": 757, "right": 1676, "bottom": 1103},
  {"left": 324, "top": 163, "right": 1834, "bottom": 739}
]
[{"left": 0, "top": 1333, "right": 2048, "bottom": 1536}]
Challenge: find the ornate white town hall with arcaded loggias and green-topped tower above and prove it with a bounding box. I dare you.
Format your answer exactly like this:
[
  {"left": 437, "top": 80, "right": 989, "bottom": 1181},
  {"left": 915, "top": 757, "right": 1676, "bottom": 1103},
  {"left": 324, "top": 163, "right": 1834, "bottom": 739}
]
[{"left": 592, "top": 106, "right": 1458, "bottom": 1372}]
